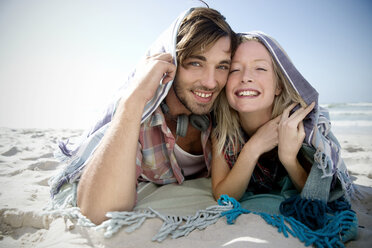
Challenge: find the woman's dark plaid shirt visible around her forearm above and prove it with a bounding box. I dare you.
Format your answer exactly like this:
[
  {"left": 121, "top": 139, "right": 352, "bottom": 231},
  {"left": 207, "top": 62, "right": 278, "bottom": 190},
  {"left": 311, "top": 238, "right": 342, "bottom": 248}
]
[{"left": 224, "top": 131, "right": 287, "bottom": 194}]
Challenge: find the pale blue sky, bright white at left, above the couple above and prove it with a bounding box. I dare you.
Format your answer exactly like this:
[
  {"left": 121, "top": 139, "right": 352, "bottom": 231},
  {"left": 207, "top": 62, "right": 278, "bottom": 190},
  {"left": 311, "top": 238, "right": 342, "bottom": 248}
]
[{"left": 0, "top": 0, "right": 372, "bottom": 129}]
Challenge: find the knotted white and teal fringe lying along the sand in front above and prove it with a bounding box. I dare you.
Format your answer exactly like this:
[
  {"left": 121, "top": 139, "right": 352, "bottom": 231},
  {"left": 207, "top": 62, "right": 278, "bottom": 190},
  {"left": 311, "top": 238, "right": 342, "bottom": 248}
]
[{"left": 45, "top": 188, "right": 358, "bottom": 244}]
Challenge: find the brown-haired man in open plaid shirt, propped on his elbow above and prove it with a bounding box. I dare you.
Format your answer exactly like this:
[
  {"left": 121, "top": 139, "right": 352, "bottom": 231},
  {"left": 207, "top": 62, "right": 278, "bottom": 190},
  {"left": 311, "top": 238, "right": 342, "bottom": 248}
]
[{"left": 54, "top": 8, "right": 235, "bottom": 224}]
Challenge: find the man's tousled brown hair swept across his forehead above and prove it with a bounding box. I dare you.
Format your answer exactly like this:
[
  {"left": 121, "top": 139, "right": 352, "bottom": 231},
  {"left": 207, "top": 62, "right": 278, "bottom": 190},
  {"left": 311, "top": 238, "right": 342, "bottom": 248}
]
[{"left": 176, "top": 7, "right": 236, "bottom": 65}]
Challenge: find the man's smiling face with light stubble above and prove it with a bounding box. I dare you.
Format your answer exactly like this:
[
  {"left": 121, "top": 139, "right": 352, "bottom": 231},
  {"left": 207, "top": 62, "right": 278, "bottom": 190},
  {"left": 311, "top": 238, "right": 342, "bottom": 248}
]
[{"left": 173, "top": 37, "right": 231, "bottom": 115}]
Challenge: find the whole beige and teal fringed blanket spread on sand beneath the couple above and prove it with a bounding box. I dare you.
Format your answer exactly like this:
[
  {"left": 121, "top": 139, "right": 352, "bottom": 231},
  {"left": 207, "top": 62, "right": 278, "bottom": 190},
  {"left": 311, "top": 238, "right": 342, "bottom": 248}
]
[{"left": 46, "top": 175, "right": 358, "bottom": 247}]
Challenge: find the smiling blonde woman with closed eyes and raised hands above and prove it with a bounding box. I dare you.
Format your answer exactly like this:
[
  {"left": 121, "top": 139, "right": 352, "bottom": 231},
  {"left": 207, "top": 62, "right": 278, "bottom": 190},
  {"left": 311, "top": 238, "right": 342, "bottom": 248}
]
[{"left": 212, "top": 33, "right": 342, "bottom": 202}]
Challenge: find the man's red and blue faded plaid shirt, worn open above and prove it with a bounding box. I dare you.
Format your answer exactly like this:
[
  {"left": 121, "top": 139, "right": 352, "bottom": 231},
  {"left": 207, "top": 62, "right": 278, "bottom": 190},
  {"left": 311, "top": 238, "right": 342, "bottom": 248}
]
[{"left": 136, "top": 107, "right": 212, "bottom": 184}]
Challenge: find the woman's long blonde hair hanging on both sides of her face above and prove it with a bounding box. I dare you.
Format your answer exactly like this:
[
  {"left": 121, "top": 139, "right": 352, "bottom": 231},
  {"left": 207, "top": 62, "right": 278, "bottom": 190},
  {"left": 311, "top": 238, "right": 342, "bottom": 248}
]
[{"left": 213, "top": 34, "right": 306, "bottom": 154}]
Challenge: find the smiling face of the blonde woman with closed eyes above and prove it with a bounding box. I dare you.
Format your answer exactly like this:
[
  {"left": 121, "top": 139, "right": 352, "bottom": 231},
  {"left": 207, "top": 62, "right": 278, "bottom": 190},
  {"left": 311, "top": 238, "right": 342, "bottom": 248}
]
[{"left": 225, "top": 41, "right": 281, "bottom": 115}]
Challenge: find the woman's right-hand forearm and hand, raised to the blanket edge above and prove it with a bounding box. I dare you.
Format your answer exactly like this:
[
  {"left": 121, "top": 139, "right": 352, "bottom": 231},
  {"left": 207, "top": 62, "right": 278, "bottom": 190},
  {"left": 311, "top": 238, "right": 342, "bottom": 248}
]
[{"left": 278, "top": 103, "right": 315, "bottom": 191}]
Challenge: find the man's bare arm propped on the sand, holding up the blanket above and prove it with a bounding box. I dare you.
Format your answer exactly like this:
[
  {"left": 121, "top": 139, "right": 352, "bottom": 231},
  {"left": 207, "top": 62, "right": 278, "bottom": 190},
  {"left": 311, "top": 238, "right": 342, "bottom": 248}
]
[{"left": 77, "top": 54, "right": 176, "bottom": 224}]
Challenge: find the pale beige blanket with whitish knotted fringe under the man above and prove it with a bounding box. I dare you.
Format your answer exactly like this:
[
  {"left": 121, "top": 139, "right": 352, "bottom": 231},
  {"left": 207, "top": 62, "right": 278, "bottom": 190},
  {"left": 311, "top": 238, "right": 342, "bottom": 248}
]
[{"left": 47, "top": 178, "right": 232, "bottom": 241}]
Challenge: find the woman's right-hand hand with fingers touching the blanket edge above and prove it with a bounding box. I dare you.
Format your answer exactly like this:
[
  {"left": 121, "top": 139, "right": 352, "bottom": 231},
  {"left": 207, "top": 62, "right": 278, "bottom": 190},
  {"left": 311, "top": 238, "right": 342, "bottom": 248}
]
[{"left": 278, "top": 102, "right": 315, "bottom": 167}]
